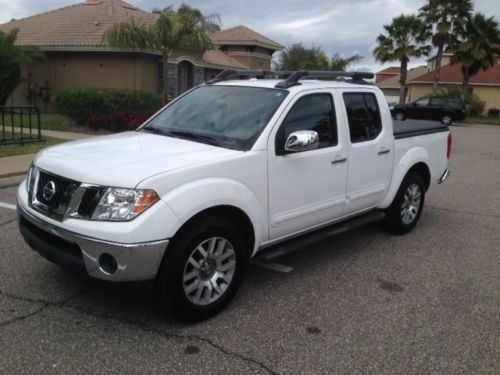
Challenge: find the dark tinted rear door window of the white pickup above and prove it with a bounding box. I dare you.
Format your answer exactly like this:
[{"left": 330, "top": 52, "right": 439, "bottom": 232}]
[{"left": 344, "top": 93, "right": 382, "bottom": 143}]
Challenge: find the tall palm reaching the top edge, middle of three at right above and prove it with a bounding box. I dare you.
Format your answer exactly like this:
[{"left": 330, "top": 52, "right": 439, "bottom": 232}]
[{"left": 419, "top": 0, "right": 473, "bottom": 95}]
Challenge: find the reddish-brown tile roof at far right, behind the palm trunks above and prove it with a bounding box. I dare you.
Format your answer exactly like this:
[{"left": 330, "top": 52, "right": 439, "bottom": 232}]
[{"left": 411, "top": 57, "right": 500, "bottom": 86}]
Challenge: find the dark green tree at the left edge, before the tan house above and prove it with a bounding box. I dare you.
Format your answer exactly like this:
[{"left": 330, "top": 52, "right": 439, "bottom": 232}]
[{"left": 0, "top": 30, "right": 44, "bottom": 105}]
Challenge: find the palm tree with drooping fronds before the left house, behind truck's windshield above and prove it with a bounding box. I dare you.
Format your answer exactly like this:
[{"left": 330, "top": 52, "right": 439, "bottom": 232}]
[{"left": 105, "top": 7, "right": 212, "bottom": 104}]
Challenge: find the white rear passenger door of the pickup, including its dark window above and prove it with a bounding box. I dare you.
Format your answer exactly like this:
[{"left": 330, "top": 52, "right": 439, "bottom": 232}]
[{"left": 341, "top": 89, "right": 394, "bottom": 214}]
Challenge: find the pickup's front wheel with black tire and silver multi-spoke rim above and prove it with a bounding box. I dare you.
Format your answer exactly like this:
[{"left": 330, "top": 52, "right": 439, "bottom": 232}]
[{"left": 155, "top": 216, "right": 249, "bottom": 322}]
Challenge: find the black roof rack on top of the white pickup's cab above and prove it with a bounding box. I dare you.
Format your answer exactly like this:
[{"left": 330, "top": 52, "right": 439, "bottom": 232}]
[{"left": 206, "top": 69, "right": 374, "bottom": 89}]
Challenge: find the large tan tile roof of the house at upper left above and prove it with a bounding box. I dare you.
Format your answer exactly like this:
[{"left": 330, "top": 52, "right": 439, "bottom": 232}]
[{"left": 0, "top": 0, "right": 158, "bottom": 47}]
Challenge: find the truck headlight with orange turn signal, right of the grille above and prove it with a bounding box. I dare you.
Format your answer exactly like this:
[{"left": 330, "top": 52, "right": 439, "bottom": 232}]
[{"left": 92, "top": 188, "right": 160, "bottom": 221}]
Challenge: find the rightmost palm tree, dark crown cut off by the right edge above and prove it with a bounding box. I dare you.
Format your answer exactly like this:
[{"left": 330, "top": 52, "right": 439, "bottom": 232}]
[{"left": 451, "top": 13, "right": 500, "bottom": 97}]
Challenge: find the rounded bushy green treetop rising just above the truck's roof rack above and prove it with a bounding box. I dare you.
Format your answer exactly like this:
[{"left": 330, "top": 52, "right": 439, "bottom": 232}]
[{"left": 276, "top": 43, "right": 329, "bottom": 70}]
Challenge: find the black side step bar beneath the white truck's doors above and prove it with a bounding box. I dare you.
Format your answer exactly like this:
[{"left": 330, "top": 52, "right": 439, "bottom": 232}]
[{"left": 255, "top": 211, "right": 385, "bottom": 262}]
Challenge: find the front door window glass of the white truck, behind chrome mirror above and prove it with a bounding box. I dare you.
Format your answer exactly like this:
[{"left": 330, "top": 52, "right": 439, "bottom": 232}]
[{"left": 276, "top": 94, "right": 337, "bottom": 154}]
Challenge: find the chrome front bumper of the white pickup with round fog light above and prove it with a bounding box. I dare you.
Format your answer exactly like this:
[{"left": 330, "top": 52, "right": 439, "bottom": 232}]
[{"left": 17, "top": 204, "right": 169, "bottom": 281}]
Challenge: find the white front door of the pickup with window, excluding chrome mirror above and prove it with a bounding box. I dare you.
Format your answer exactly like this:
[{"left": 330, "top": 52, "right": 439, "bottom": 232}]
[{"left": 268, "top": 92, "right": 347, "bottom": 240}]
